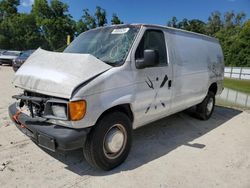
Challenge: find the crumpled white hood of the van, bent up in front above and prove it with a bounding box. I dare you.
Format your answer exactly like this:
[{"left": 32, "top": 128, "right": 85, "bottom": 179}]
[{"left": 13, "top": 48, "right": 111, "bottom": 99}]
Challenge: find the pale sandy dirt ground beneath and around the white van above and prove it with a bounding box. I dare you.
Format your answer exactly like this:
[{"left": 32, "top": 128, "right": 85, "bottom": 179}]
[{"left": 0, "top": 66, "right": 250, "bottom": 188}]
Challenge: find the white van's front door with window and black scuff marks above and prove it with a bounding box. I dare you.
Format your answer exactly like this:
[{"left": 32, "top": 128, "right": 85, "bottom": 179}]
[{"left": 133, "top": 29, "right": 172, "bottom": 127}]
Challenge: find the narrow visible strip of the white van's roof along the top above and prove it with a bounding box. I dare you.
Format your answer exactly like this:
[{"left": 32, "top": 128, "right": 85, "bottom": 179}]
[{"left": 109, "top": 23, "right": 218, "bottom": 42}]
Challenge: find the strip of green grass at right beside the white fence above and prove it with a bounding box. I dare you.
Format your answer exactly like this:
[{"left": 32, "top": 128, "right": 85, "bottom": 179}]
[{"left": 224, "top": 78, "right": 250, "bottom": 94}]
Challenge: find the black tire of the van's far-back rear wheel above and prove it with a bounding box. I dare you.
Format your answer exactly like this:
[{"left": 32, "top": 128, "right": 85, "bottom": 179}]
[{"left": 196, "top": 91, "right": 215, "bottom": 120}]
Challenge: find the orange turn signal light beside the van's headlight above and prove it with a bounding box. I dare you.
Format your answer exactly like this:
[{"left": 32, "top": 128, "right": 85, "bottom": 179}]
[{"left": 69, "top": 100, "right": 87, "bottom": 121}]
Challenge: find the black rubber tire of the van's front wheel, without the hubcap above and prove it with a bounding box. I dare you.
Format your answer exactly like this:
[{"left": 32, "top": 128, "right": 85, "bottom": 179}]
[{"left": 83, "top": 111, "right": 132, "bottom": 170}]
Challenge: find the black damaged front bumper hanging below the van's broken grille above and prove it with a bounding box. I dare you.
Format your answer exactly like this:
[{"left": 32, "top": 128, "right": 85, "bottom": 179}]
[{"left": 9, "top": 103, "right": 89, "bottom": 151}]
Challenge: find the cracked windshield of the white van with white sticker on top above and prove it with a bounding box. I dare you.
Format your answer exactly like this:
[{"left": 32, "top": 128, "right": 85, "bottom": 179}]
[{"left": 64, "top": 26, "right": 139, "bottom": 66}]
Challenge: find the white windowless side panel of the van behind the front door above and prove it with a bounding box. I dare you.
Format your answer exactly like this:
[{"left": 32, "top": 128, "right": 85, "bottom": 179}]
[{"left": 168, "top": 30, "right": 223, "bottom": 112}]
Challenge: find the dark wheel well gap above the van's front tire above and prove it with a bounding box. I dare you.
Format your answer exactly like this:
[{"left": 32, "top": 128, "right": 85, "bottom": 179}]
[{"left": 97, "top": 104, "right": 134, "bottom": 122}]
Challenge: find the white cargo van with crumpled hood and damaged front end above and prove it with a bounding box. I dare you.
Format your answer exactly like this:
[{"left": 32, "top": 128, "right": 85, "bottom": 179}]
[{"left": 9, "top": 24, "right": 224, "bottom": 170}]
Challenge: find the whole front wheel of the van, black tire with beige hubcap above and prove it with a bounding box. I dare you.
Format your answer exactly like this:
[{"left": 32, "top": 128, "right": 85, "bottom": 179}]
[{"left": 83, "top": 112, "right": 132, "bottom": 170}]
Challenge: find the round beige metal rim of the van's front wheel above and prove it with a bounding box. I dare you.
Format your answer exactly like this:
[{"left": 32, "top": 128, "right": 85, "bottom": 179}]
[{"left": 103, "top": 124, "right": 127, "bottom": 159}]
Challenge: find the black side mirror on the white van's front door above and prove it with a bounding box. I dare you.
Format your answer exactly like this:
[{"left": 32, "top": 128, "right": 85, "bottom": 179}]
[{"left": 135, "top": 50, "right": 159, "bottom": 69}]
